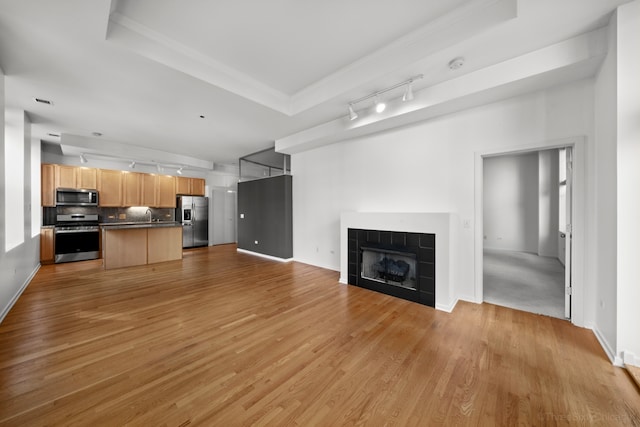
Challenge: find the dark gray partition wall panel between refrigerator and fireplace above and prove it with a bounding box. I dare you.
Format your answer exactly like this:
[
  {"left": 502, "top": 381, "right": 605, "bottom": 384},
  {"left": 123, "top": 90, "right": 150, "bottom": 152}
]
[{"left": 238, "top": 175, "right": 293, "bottom": 259}]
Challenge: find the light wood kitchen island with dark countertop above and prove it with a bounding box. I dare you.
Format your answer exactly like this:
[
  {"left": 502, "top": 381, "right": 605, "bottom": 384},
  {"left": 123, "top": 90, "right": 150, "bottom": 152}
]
[{"left": 100, "top": 221, "right": 182, "bottom": 269}]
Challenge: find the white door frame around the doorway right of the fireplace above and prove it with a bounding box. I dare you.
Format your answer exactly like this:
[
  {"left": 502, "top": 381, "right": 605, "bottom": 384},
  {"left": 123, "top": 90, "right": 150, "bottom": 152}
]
[{"left": 474, "top": 136, "right": 586, "bottom": 326}]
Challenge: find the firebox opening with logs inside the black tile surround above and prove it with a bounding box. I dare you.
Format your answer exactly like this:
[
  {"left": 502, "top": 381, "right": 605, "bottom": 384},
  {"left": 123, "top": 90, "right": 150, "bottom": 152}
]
[{"left": 360, "top": 247, "right": 417, "bottom": 290}]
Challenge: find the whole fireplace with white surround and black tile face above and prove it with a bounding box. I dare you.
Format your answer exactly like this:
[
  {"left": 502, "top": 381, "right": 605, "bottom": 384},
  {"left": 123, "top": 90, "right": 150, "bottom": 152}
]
[{"left": 340, "top": 212, "right": 456, "bottom": 311}]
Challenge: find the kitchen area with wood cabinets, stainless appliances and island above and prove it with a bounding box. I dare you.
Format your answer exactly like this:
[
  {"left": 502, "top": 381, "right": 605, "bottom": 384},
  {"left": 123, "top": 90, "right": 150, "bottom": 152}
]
[{"left": 40, "top": 164, "right": 214, "bottom": 269}]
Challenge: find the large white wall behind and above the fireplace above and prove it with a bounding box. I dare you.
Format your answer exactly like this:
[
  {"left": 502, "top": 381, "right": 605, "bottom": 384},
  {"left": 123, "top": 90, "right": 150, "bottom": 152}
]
[{"left": 292, "top": 80, "right": 596, "bottom": 320}]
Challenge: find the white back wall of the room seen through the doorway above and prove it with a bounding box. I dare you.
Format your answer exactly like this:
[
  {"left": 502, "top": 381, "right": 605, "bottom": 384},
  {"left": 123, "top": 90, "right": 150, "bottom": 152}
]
[{"left": 483, "top": 152, "right": 539, "bottom": 253}]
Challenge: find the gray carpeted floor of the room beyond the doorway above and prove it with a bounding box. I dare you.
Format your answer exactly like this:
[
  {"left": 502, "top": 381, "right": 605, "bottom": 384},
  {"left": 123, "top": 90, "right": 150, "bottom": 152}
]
[{"left": 483, "top": 249, "right": 565, "bottom": 319}]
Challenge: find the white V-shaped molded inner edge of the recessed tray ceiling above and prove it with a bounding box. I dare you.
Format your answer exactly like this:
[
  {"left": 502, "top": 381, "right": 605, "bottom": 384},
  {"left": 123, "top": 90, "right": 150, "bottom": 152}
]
[{"left": 106, "top": 0, "right": 517, "bottom": 116}]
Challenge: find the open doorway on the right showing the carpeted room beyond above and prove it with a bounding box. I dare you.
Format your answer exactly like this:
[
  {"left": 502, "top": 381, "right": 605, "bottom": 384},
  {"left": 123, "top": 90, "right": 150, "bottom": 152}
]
[{"left": 482, "top": 147, "right": 572, "bottom": 319}]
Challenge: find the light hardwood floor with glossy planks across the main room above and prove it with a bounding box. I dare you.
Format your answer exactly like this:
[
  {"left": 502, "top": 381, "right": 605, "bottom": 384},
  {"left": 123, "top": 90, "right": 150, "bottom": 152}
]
[{"left": 0, "top": 245, "right": 640, "bottom": 426}]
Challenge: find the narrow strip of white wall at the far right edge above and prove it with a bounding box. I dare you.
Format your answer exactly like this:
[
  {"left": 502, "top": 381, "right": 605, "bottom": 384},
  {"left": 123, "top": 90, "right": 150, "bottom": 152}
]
[{"left": 617, "top": 0, "right": 640, "bottom": 366}]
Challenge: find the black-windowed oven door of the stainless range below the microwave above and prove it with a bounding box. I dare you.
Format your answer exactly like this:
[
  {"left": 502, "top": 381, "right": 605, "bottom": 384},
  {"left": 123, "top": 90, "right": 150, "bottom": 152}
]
[{"left": 54, "top": 227, "right": 100, "bottom": 263}]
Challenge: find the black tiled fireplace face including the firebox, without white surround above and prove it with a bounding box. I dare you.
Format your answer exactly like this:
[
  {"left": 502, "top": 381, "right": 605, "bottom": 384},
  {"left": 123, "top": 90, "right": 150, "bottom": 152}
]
[{"left": 348, "top": 228, "right": 435, "bottom": 307}]
